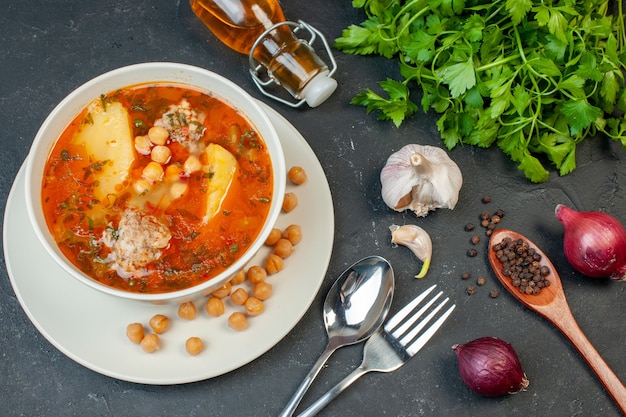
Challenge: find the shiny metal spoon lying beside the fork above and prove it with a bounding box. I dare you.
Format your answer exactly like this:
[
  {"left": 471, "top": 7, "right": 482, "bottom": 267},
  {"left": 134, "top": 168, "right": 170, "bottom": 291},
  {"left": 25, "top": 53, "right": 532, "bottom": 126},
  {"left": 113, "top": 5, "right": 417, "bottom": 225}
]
[{"left": 280, "top": 256, "right": 394, "bottom": 417}]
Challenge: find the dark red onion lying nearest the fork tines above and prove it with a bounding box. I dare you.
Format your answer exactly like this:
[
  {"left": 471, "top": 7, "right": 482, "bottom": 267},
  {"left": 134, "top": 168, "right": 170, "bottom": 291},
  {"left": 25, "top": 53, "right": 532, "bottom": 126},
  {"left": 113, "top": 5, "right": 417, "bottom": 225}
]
[{"left": 452, "top": 337, "right": 529, "bottom": 397}]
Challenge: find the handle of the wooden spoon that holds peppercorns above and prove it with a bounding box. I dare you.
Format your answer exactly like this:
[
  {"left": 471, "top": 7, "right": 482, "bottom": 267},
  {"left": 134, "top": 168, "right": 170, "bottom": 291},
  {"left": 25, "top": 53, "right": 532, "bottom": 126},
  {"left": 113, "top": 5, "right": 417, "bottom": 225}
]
[{"left": 554, "top": 314, "right": 626, "bottom": 415}]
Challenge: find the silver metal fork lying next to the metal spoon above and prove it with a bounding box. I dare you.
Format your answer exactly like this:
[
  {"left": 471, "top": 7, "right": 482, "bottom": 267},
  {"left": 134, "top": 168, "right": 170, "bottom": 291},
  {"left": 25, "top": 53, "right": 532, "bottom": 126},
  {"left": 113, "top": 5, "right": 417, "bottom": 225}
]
[{"left": 292, "top": 285, "right": 455, "bottom": 417}]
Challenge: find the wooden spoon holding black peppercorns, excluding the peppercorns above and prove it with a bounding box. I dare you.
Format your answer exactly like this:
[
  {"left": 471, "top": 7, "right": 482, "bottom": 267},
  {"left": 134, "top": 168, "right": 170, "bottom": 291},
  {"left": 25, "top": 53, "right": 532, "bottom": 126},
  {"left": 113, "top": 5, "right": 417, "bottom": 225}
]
[{"left": 489, "top": 229, "right": 626, "bottom": 415}]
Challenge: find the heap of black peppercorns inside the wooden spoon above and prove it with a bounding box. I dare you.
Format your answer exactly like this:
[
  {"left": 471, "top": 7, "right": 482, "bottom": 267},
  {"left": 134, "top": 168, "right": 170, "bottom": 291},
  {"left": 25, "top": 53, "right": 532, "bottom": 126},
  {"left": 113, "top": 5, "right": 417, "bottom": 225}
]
[{"left": 493, "top": 237, "right": 550, "bottom": 294}]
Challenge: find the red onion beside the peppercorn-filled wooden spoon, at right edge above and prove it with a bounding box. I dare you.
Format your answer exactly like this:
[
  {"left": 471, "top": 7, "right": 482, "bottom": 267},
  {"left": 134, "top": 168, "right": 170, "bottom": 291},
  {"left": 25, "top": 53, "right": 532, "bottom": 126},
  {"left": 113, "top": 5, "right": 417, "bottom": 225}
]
[{"left": 555, "top": 204, "right": 626, "bottom": 281}]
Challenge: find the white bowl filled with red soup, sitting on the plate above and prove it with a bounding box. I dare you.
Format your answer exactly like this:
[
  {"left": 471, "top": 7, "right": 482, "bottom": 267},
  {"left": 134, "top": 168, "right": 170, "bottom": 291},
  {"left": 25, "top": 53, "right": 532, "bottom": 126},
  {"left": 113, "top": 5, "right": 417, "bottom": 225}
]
[{"left": 25, "top": 63, "right": 286, "bottom": 302}]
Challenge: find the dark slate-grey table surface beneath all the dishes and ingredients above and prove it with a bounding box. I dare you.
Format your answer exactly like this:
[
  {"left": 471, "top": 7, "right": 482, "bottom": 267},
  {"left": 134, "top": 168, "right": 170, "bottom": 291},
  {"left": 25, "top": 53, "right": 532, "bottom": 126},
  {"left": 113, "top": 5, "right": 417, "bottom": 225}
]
[{"left": 0, "top": 0, "right": 626, "bottom": 417}]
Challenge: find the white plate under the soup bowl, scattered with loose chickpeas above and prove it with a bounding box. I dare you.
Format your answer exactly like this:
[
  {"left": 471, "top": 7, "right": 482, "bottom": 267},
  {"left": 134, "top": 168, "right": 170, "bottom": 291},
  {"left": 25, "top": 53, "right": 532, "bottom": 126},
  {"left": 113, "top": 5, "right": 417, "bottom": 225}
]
[{"left": 4, "top": 105, "right": 334, "bottom": 384}]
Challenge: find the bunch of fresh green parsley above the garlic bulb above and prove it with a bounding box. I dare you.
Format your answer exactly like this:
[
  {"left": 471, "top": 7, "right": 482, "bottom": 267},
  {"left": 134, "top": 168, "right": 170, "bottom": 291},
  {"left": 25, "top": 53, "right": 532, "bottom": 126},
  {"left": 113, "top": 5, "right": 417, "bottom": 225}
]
[{"left": 335, "top": 0, "right": 626, "bottom": 183}]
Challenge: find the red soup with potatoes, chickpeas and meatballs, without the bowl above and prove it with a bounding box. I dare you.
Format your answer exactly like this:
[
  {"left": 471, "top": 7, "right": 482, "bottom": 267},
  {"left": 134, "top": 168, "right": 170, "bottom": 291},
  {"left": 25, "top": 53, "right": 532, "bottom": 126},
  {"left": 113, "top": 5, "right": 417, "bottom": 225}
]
[{"left": 41, "top": 84, "right": 273, "bottom": 293}]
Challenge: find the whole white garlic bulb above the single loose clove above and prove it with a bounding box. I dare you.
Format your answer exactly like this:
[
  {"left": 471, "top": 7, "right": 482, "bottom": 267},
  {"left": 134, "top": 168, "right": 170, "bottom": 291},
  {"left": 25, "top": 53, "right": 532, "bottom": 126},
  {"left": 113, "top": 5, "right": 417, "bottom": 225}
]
[{"left": 380, "top": 144, "right": 463, "bottom": 217}]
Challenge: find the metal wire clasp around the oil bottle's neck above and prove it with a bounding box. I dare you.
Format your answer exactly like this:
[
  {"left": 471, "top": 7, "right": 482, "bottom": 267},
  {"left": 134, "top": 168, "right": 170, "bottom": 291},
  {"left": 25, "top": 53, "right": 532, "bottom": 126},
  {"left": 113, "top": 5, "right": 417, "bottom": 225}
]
[{"left": 248, "top": 20, "right": 337, "bottom": 108}]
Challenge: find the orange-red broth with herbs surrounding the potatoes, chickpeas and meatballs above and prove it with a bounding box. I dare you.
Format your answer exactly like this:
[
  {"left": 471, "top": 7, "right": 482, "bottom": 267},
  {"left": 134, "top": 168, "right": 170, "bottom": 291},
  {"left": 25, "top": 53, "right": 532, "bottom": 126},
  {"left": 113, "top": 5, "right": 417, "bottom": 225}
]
[{"left": 42, "top": 84, "right": 273, "bottom": 293}]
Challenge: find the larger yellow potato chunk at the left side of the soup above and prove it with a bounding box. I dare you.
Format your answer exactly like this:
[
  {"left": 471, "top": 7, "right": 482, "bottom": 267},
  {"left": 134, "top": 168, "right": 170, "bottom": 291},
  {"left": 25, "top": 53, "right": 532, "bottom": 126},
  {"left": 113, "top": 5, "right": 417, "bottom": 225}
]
[{"left": 74, "top": 99, "right": 135, "bottom": 201}]
